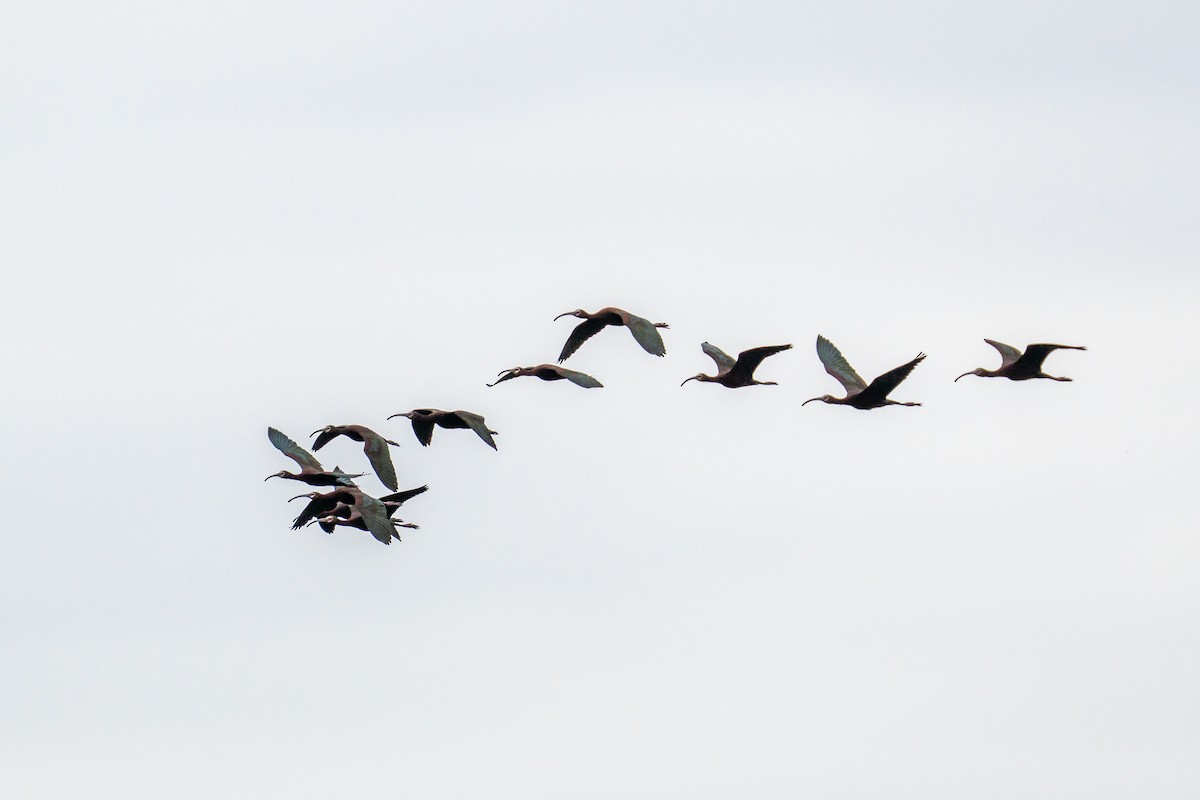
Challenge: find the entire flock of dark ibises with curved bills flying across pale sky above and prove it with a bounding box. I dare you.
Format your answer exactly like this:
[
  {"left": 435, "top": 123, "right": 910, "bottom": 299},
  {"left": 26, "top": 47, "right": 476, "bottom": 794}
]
[{"left": 264, "top": 307, "right": 1087, "bottom": 545}]
